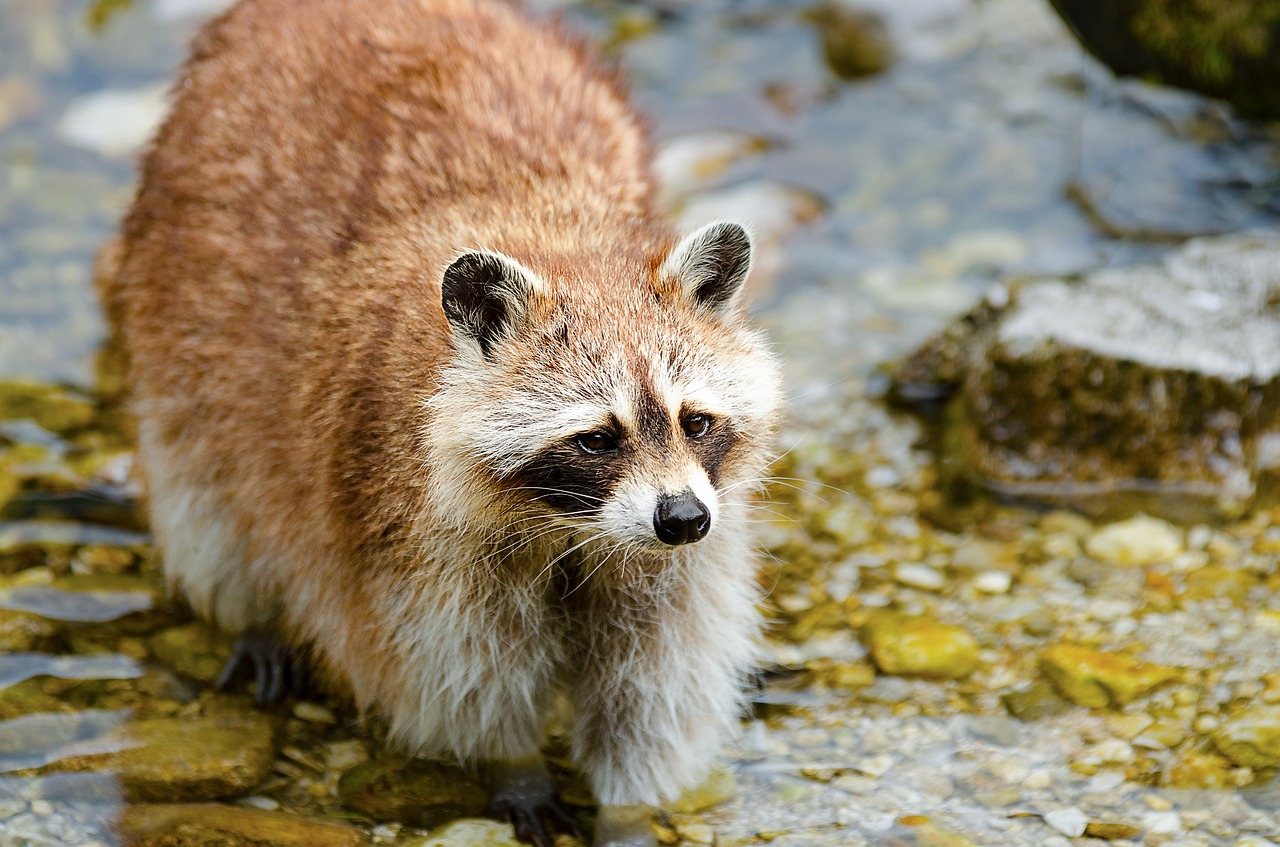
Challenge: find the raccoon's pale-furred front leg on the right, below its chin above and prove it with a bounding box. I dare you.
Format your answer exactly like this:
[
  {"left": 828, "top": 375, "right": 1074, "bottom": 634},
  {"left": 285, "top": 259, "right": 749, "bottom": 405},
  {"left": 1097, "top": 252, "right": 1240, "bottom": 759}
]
[{"left": 571, "top": 545, "right": 759, "bottom": 829}]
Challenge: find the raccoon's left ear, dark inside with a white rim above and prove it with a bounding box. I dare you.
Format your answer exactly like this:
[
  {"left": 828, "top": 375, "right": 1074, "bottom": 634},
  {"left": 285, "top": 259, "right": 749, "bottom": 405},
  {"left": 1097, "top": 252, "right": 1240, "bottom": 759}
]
[{"left": 440, "top": 251, "right": 540, "bottom": 358}]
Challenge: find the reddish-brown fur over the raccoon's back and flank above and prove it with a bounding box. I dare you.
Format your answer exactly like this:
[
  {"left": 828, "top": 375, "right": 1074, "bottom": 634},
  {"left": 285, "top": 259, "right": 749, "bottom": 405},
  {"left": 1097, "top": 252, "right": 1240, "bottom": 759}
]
[{"left": 100, "top": 0, "right": 764, "bottom": 813}]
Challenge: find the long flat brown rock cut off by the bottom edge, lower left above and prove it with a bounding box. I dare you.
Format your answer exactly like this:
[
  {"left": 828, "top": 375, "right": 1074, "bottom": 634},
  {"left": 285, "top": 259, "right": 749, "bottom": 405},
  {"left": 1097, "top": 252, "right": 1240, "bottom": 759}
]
[{"left": 116, "top": 803, "right": 369, "bottom": 847}]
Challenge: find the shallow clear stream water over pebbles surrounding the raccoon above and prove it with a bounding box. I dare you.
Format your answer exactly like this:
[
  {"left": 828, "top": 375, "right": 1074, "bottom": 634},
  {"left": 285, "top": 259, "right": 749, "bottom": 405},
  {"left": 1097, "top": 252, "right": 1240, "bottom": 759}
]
[{"left": 0, "top": 0, "right": 1280, "bottom": 847}]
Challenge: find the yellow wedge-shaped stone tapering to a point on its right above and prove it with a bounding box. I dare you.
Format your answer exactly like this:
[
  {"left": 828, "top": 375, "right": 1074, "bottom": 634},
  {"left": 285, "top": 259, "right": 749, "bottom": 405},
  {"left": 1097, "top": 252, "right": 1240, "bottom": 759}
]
[{"left": 1039, "top": 644, "right": 1178, "bottom": 709}]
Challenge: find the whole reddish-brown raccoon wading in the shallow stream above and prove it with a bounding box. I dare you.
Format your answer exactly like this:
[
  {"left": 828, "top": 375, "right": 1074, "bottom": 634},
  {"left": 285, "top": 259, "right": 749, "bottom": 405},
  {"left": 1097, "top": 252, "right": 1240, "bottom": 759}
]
[{"left": 99, "top": 0, "right": 781, "bottom": 844}]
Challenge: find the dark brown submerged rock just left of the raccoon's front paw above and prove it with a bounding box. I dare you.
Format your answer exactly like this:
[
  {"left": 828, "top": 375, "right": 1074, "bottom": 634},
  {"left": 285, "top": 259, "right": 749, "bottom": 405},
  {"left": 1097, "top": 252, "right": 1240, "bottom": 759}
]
[{"left": 338, "top": 759, "right": 486, "bottom": 829}]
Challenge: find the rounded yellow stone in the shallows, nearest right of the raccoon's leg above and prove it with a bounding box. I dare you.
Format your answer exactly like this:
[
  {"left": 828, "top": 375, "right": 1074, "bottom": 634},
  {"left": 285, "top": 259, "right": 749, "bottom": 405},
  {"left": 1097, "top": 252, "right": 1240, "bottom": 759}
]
[{"left": 861, "top": 612, "right": 979, "bottom": 679}]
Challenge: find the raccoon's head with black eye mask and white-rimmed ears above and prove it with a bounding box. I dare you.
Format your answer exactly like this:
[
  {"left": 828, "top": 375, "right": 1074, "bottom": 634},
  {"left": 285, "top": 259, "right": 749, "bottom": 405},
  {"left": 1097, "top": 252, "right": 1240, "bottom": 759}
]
[{"left": 429, "top": 223, "right": 780, "bottom": 551}]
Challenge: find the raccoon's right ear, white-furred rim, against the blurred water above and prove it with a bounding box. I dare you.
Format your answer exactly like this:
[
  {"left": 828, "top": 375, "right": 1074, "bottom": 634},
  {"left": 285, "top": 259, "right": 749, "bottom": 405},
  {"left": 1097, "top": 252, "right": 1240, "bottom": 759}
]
[{"left": 659, "top": 221, "right": 751, "bottom": 315}]
